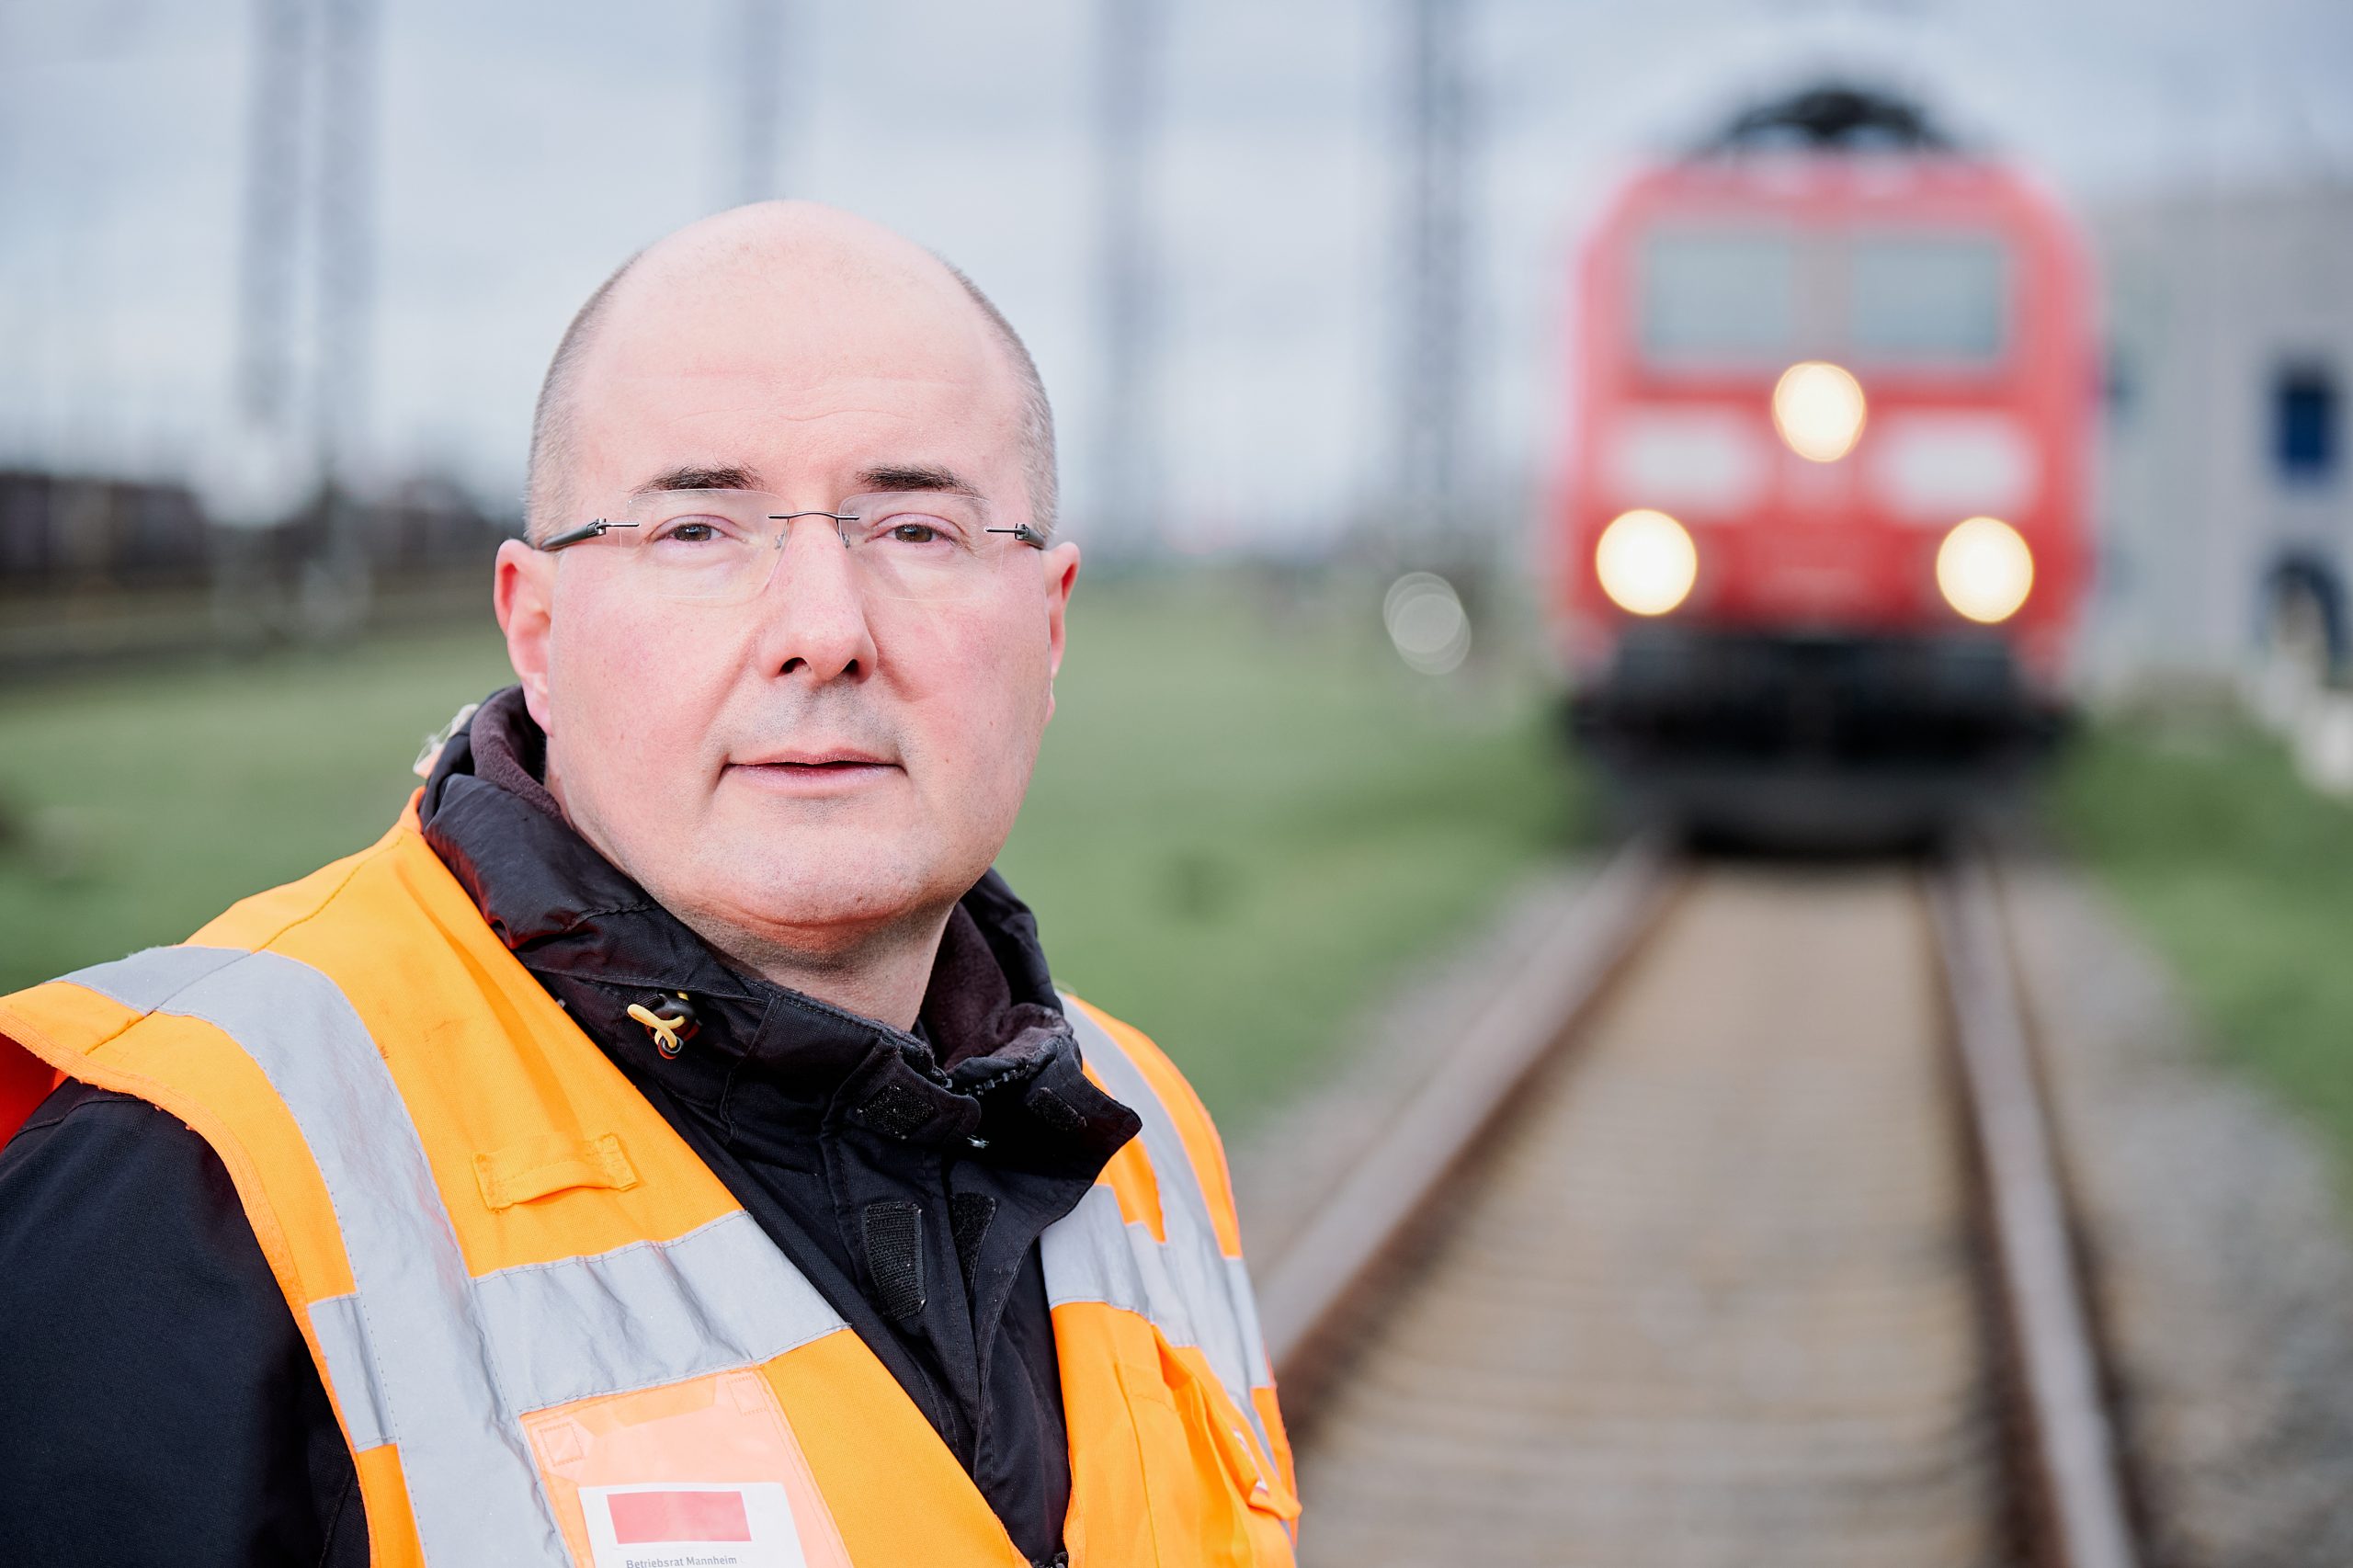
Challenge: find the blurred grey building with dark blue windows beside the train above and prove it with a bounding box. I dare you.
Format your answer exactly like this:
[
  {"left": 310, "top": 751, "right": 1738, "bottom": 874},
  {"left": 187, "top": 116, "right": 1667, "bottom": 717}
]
[{"left": 2092, "top": 179, "right": 2353, "bottom": 687}]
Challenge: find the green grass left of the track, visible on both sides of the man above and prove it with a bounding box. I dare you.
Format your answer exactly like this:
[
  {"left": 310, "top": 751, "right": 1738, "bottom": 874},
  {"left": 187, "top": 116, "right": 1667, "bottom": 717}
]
[{"left": 0, "top": 579, "right": 1581, "bottom": 1123}]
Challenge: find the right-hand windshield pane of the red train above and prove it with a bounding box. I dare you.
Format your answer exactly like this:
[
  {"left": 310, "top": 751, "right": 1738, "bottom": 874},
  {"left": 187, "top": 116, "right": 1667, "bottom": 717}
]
[{"left": 1847, "top": 233, "right": 2009, "bottom": 362}]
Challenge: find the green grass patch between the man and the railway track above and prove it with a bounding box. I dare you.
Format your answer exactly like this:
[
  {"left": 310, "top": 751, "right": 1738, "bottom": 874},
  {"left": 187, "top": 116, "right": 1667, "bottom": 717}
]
[{"left": 1003, "top": 574, "right": 1586, "bottom": 1131}]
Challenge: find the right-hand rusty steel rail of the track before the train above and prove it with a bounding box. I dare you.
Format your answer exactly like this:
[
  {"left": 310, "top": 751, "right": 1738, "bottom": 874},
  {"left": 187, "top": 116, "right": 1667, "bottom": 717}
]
[{"left": 1927, "top": 847, "right": 2142, "bottom": 1568}]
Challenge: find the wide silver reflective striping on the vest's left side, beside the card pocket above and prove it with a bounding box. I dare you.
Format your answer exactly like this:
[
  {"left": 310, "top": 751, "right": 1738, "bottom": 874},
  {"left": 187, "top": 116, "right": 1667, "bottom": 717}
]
[{"left": 66, "top": 947, "right": 845, "bottom": 1565}]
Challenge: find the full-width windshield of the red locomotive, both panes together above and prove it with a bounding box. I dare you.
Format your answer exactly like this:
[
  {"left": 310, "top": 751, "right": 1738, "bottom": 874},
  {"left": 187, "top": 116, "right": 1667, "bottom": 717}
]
[{"left": 1638, "top": 226, "right": 2009, "bottom": 369}]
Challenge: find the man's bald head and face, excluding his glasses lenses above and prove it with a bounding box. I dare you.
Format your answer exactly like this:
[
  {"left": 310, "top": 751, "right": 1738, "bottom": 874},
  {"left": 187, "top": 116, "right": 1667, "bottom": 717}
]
[{"left": 496, "top": 202, "right": 1077, "bottom": 988}]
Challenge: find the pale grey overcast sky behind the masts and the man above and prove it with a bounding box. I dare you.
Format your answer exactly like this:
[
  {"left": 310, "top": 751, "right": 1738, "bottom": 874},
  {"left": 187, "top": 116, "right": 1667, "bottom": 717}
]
[{"left": 0, "top": 0, "right": 2353, "bottom": 537}]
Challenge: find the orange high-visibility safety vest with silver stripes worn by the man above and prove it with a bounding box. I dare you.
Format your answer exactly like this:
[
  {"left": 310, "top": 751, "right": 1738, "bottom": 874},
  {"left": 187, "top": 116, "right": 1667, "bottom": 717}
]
[{"left": 0, "top": 801, "right": 1299, "bottom": 1568}]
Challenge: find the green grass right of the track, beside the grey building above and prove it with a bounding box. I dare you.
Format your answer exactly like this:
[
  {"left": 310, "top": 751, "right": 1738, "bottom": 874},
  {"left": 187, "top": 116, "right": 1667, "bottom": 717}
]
[{"left": 2052, "top": 721, "right": 2353, "bottom": 1167}]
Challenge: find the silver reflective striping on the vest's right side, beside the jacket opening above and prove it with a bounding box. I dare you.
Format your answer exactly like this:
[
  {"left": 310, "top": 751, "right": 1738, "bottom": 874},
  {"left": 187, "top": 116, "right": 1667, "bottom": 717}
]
[{"left": 1040, "top": 1001, "right": 1276, "bottom": 1460}]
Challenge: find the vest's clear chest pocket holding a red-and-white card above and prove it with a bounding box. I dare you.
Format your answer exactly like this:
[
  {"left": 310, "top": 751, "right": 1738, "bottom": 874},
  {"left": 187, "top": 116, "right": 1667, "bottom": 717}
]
[{"left": 522, "top": 1368, "right": 849, "bottom": 1568}]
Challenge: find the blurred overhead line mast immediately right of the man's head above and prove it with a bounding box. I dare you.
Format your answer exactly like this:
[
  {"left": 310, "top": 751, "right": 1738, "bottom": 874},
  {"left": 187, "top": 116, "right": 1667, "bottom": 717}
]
[{"left": 1094, "top": 0, "right": 1165, "bottom": 549}]
